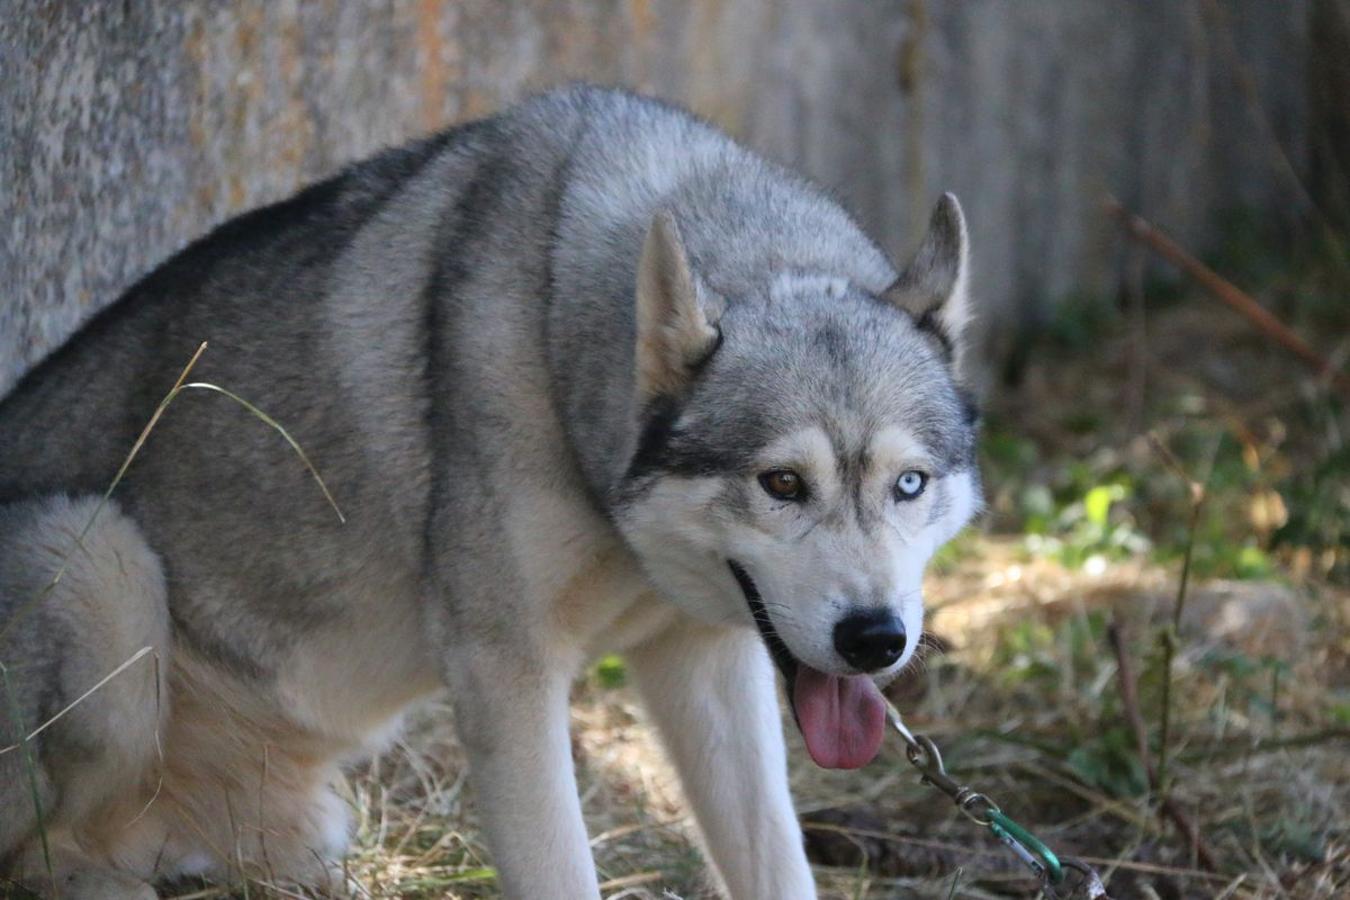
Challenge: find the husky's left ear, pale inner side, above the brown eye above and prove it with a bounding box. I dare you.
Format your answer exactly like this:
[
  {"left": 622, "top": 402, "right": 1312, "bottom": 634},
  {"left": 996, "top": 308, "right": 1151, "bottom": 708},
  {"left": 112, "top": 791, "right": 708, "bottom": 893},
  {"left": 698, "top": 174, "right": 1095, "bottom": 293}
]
[{"left": 636, "top": 210, "right": 724, "bottom": 399}]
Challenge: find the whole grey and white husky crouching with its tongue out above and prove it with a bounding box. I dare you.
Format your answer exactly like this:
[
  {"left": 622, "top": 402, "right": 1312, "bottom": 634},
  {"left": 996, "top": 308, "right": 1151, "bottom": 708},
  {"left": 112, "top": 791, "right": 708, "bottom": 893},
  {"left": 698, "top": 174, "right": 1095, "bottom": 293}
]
[{"left": 0, "top": 86, "right": 980, "bottom": 900}]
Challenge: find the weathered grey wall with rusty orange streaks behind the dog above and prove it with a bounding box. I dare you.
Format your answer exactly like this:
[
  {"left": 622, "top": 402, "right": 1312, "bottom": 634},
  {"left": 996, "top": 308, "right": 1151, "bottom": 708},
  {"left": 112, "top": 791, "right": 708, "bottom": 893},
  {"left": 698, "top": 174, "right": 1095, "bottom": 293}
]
[{"left": 0, "top": 0, "right": 1308, "bottom": 391}]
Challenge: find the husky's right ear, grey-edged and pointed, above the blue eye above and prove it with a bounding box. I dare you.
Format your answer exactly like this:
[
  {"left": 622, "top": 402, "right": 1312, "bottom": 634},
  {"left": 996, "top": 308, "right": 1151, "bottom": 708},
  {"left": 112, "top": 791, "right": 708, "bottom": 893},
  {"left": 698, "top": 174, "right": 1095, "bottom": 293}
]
[{"left": 884, "top": 194, "right": 971, "bottom": 371}]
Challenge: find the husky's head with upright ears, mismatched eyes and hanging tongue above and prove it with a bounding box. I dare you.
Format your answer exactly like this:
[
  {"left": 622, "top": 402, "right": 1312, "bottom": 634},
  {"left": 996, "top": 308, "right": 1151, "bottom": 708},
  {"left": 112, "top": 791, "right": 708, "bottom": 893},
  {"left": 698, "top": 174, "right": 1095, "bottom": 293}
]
[{"left": 614, "top": 196, "right": 980, "bottom": 768}]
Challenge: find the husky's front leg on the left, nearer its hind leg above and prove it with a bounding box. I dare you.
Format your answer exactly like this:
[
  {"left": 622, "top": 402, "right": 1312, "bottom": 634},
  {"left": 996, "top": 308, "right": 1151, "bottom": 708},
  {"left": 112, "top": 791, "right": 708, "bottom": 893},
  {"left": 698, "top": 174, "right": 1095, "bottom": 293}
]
[{"left": 450, "top": 646, "right": 599, "bottom": 900}]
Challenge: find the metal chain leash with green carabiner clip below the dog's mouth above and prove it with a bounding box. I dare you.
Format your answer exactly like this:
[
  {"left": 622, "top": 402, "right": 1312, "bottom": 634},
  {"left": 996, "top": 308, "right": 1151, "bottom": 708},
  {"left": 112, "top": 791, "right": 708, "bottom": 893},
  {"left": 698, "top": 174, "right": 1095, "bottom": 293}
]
[{"left": 886, "top": 702, "right": 1110, "bottom": 900}]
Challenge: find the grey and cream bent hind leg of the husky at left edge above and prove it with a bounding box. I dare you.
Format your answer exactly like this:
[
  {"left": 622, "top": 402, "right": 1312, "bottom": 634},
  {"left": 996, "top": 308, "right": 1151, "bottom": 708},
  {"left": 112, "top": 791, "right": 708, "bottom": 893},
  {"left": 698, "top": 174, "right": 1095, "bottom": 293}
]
[{"left": 0, "top": 497, "right": 170, "bottom": 900}]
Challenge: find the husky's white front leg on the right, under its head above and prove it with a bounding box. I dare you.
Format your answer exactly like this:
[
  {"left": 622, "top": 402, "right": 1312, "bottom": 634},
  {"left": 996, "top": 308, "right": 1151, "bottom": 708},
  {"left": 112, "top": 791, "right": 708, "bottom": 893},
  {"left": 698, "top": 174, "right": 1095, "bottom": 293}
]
[{"left": 628, "top": 621, "right": 815, "bottom": 900}]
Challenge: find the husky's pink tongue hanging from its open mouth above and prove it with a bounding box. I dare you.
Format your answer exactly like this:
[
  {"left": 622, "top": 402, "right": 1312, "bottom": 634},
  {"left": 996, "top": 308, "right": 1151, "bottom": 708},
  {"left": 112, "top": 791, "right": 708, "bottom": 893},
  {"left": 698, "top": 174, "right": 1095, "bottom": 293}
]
[{"left": 792, "top": 664, "right": 886, "bottom": 769}]
